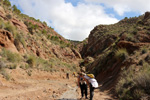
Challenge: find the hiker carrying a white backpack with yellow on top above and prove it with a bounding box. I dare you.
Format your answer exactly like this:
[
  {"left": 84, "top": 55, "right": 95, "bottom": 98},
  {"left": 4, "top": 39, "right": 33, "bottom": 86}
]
[{"left": 82, "top": 73, "right": 98, "bottom": 100}]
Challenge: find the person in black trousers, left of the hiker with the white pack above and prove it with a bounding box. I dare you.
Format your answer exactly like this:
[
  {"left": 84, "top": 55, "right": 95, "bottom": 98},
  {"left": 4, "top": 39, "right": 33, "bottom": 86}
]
[{"left": 78, "top": 73, "right": 88, "bottom": 99}]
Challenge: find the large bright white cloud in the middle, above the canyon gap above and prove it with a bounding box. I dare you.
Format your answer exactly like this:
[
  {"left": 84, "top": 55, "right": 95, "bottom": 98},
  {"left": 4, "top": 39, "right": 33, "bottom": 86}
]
[{"left": 10, "top": 0, "right": 118, "bottom": 40}]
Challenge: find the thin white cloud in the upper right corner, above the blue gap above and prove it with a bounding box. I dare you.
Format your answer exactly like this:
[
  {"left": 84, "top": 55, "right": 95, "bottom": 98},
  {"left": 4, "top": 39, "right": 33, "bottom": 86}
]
[{"left": 85, "top": 0, "right": 150, "bottom": 16}]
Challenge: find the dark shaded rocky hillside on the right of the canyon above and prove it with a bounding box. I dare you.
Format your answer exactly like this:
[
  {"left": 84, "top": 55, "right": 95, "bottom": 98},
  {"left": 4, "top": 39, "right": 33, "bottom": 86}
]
[{"left": 81, "top": 12, "right": 150, "bottom": 100}]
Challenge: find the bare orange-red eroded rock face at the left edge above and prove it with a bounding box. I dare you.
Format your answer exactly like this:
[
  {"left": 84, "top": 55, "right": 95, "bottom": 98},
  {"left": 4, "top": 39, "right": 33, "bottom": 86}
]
[{"left": 0, "top": 30, "right": 18, "bottom": 52}]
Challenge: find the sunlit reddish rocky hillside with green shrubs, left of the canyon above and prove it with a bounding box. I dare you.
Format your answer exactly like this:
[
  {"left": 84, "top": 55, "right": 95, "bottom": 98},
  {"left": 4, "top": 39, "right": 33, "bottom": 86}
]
[{"left": 0, "top": 0, "right": 81, "bottom": 72}]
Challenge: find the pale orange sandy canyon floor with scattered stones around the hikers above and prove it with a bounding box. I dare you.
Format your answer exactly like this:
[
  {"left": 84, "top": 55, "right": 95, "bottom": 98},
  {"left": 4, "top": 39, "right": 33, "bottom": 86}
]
[{"left": 0, "top": 68, "right": 117, "bottom": 100}]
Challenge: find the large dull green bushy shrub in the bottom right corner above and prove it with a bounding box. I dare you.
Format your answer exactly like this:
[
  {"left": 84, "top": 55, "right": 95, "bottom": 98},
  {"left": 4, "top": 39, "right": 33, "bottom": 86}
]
[{"left": 116, "top": 63, "right": 150, "bottom": 100}]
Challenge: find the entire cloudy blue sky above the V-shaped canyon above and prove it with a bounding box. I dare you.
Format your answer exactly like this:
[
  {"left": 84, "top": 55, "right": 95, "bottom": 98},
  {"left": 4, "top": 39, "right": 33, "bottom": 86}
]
[{"left": 10, "top": 0, "right": 150, "bottom": 41}]
